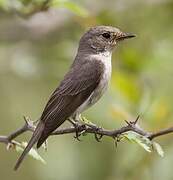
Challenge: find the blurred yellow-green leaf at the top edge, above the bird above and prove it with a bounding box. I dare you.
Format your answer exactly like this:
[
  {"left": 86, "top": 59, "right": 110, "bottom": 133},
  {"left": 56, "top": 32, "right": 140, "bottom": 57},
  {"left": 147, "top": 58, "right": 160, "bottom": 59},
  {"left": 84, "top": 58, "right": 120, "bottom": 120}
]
[{"left": 50, "top": 0, "right": 89, "bottom": 17}]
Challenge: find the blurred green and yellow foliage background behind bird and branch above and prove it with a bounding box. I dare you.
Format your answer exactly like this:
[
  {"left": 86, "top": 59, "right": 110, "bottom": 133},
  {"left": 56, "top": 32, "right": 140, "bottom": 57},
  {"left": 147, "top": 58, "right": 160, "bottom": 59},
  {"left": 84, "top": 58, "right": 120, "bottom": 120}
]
[{"left": 0, "top": 0, "right": 173, "bottom": 180}]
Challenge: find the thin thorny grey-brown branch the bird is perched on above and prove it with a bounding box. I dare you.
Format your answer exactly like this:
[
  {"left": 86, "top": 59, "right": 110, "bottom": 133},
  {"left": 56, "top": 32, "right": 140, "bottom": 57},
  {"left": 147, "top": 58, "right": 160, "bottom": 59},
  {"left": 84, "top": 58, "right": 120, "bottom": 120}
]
[{"left": 0, "top": 116, "right": 173, "bottom": 148}]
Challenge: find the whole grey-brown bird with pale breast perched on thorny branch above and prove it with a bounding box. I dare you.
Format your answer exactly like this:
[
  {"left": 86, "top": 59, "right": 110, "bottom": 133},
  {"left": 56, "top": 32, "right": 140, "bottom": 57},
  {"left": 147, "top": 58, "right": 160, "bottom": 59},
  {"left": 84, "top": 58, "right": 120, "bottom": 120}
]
[{"left": 14, "top": 25, "right": 135, "bottom": 170}]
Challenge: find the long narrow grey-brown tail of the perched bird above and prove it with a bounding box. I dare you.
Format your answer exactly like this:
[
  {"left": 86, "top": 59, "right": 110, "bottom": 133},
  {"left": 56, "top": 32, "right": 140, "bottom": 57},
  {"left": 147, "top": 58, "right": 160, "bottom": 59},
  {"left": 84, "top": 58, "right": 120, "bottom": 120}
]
[{"left": 14, "top": 121, "right": 44, "bottom": 171}]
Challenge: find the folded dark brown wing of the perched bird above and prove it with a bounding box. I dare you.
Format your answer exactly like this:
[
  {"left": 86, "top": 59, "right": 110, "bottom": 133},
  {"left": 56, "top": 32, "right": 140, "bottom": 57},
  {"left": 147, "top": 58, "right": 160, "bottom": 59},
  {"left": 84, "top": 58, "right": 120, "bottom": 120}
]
[{"left": 37, "top": 60, "right": 103, "bottom": 147}]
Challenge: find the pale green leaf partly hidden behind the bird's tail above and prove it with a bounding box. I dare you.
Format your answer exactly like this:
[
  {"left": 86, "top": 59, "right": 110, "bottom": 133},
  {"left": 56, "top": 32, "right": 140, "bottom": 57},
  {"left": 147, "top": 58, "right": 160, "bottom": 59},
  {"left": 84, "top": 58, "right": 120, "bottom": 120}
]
[{"left": 14, "top": 142, "right": 46, "bottom": 164}]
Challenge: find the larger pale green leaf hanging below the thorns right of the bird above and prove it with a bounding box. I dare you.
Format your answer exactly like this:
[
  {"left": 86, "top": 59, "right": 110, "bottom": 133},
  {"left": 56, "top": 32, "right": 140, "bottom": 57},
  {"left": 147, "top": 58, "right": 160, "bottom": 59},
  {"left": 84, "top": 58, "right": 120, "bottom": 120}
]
[{"left": 123, "top": 131, "right": 152, "bottom": 152}]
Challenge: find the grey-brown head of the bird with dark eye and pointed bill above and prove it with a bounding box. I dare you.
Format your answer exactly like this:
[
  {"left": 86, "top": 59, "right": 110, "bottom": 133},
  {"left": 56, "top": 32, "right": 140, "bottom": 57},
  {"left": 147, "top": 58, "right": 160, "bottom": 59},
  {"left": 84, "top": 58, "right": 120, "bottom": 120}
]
[{"left": 79, "top": 26, "right": 135, "bottom": 52}]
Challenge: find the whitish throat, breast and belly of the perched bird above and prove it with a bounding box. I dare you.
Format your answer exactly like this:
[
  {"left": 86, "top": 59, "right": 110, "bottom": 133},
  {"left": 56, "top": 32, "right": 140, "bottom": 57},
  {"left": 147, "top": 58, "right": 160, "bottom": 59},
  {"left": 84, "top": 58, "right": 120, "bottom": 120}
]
[{"left": 75, "top": 52, "right": 112, "bottom": 114}]
